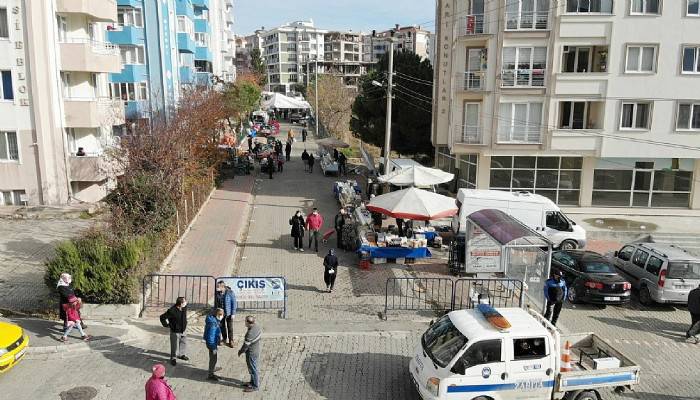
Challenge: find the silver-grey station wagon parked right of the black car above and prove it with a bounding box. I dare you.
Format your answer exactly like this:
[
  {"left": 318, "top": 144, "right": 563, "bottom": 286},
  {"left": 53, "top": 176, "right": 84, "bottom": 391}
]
[{"left": 608, "top": 243, "right": 700, "bottom": 305}]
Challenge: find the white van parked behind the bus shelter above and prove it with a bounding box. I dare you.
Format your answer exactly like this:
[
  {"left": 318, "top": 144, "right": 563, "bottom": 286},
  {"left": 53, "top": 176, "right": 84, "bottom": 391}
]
[{"left": 452, "top": 189, "right": 586, "bottom": 250}]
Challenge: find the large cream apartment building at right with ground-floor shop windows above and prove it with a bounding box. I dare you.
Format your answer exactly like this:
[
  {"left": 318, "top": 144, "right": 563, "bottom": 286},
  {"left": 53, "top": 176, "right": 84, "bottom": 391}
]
[{"left": 432, "top": 0, "right": 700, "bottom": 209}]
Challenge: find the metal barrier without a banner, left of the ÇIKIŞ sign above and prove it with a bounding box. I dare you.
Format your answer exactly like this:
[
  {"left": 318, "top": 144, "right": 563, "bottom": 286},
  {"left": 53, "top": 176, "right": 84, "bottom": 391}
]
[{"left": 143, "top": 274, "right": 215, "bottom": 309}]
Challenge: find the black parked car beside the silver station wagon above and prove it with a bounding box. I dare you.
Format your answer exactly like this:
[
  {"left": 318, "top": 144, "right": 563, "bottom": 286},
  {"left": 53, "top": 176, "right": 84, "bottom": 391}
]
[{"left": 552, "top": 250, "right": 632, "bottom": 304}]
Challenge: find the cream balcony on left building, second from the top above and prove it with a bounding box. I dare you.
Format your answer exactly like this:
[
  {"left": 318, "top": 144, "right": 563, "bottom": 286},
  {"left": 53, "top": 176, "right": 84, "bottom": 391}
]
[{"left": 59, "top": 38, "right": 122, "bottom": 73}]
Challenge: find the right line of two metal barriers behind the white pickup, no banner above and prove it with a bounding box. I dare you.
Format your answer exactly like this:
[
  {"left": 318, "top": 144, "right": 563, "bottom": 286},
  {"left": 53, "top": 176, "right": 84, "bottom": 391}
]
[{"left": 384, "top": 278, "right": 525, "bottom": 319}]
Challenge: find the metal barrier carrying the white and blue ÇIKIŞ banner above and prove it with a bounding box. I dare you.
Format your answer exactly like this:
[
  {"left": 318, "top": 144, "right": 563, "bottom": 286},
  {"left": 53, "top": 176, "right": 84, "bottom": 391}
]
[{"left": 216, "top": 276, "right": 287, "bottom": 318}]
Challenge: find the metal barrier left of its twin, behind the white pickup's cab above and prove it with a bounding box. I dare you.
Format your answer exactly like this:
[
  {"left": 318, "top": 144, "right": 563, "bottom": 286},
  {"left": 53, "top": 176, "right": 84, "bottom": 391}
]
[{"left": 384, "top": 278, "right": 454, "bottom": 319}]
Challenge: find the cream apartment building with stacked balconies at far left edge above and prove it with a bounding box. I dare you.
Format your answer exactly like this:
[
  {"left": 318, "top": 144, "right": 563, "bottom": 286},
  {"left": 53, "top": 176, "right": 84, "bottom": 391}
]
[{"left": 0, "top": 0, "right": 124, "bottom": 205}]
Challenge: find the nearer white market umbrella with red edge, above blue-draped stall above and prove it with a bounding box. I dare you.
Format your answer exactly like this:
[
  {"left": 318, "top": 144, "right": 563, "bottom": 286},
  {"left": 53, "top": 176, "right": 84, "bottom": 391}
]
[{"left": 367, "top": 188, "right": 458, "bottom": 221}]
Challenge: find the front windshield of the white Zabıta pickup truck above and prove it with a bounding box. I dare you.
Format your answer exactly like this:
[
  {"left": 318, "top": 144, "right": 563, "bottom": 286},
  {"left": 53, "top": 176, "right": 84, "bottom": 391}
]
[{"left": 421, "top": 315, "right": 467, "bottom": 368}]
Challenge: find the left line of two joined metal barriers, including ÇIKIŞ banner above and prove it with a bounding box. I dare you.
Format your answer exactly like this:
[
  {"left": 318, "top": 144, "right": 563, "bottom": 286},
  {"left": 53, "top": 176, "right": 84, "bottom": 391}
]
[{"left": 142, "top": 274, "right": 287, "bottom": 318}]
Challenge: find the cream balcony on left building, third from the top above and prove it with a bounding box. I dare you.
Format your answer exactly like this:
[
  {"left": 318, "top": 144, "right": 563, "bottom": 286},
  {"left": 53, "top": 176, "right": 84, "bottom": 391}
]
[{"left": 63, "top": 97, "right": 124, "bottom": 128}]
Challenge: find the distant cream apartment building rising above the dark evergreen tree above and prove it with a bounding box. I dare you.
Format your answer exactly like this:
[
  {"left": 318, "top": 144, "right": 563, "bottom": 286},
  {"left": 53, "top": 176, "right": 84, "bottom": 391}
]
[{"left": 362, "top": 24, "right": 433, "bottom": 63}]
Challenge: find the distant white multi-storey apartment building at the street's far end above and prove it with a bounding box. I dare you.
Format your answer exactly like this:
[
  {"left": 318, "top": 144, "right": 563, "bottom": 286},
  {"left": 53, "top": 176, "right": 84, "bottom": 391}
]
[{"left": 262, "top": 20, "right": 328, "bottom": 93}]
